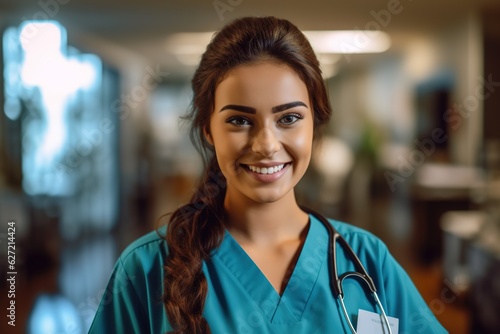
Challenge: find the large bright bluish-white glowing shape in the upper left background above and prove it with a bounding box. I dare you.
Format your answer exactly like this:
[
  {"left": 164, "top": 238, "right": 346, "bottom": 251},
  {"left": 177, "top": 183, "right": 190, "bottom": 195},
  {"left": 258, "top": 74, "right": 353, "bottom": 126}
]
[{"left": 3, "top": 21, "right": 101, "bottom": 195}]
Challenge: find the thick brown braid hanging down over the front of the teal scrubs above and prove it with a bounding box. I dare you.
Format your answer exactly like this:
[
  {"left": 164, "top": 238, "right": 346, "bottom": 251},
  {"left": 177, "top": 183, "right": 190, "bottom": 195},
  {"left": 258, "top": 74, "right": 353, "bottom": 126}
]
[{"left": 163, "top": 158, "right": 225, "bottom": 334}]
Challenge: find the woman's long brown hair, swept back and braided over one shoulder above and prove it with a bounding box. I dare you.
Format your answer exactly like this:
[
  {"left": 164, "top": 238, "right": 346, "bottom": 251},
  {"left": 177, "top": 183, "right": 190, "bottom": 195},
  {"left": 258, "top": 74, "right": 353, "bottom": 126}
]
[{"left": 163, "top": 17, "right": 331, "bottom": 334}]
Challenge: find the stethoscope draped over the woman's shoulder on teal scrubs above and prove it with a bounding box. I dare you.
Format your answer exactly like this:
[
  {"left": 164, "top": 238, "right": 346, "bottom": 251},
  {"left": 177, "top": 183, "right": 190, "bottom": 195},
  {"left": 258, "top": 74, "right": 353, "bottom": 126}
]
[{"left": 302, "top": 207, "right": 392, "bottom": 334}]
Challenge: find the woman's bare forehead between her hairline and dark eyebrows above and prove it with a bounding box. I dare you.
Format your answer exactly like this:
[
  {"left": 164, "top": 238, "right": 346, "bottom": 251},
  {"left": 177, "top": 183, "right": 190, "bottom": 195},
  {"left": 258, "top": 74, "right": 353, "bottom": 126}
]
[{"left": 215, "top": 62, "right": 309, "bottom": 107}]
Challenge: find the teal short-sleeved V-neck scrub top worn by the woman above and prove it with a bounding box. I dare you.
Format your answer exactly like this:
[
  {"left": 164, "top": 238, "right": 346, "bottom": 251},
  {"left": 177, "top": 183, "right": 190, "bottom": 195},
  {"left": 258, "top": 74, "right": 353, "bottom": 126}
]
[{"left": 89, "top": 215, "right": 447, "bottom": 334}]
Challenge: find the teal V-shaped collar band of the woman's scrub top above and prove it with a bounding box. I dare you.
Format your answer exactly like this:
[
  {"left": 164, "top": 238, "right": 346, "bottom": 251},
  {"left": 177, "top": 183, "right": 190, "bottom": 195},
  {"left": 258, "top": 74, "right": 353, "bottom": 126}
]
[{"left": 213, "top": 215, "right": 328, "bottom": 323}]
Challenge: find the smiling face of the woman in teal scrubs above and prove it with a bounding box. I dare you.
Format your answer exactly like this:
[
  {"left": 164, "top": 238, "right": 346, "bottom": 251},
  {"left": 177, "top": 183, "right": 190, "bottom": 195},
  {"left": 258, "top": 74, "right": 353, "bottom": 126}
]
[{"left": 206, "top": 62, "right": 313, "bottom": 203}]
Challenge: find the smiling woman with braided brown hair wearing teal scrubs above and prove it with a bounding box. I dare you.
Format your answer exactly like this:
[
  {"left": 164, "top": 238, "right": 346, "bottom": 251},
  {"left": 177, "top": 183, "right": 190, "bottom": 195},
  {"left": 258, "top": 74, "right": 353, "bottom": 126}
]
[{"left": 90, "top": 17, "right": 446, "bottom": 333}]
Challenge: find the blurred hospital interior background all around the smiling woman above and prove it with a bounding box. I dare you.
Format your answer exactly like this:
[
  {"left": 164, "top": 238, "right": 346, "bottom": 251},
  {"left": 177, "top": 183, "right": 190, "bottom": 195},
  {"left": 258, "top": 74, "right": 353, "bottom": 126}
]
[{"left": 0, "top": 0, "right": 500, "bottom": 333}]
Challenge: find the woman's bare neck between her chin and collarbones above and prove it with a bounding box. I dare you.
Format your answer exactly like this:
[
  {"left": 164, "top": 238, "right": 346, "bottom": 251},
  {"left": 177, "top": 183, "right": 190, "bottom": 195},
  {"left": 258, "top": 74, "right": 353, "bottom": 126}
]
[{"left": 224, "top": 191, "right": 309, "bottom": 245}]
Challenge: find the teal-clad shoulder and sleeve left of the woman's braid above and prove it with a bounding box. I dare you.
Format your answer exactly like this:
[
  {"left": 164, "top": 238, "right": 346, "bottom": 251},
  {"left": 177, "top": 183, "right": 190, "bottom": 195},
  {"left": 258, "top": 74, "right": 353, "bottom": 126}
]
[{"left": 89, "top": 231, "right": 166, "bottom": 333}]
